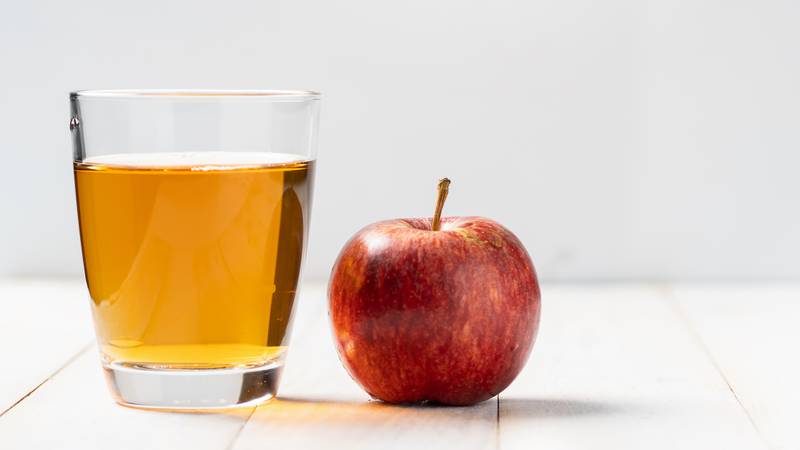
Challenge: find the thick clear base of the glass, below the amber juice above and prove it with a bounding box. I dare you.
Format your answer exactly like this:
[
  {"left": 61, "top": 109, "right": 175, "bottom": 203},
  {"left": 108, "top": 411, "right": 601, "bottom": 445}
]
[{"left": 103, "top": 362, "right": 283, "bottom": 410}]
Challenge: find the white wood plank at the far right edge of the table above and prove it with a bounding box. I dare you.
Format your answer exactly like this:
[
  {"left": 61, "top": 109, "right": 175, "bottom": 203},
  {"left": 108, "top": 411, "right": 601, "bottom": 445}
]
[{"left": 673, "top": 284, "right": 800, "bottom": 449}]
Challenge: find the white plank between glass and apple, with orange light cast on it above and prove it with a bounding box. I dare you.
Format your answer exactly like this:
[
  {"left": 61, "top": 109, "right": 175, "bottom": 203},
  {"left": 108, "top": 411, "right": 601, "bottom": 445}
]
[{"left": 228, "top": 289, "right": 497, "bottom": 450}]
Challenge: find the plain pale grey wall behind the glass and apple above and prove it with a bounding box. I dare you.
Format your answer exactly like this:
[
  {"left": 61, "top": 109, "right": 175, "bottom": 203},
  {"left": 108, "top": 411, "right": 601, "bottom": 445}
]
[{"left": 0, "top": 0, "right": 800, "bottom": 280}]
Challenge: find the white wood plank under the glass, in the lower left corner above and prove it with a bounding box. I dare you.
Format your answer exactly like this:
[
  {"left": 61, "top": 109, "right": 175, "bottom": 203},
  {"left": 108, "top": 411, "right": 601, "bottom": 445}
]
[{"left": 0, "top": 347, "right": 252, "bottom": 450}]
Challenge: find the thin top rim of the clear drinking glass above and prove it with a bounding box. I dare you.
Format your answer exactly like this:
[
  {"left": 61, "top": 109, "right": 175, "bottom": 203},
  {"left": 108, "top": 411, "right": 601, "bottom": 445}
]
[{"left": 69, "top": 89, "right": 322, "bottom": 101}]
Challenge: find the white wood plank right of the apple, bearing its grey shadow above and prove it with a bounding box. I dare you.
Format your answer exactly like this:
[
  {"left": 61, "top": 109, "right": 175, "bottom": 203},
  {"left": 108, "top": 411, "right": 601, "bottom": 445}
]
[{"left": 499, "top": 286, "right": 764, "bottom": 450}]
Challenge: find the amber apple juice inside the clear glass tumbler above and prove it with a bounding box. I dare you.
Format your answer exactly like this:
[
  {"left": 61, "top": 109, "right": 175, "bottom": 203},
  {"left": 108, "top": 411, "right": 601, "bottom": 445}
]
[{"left": 75, "top": 153, "right": 313, "bottom": 369}]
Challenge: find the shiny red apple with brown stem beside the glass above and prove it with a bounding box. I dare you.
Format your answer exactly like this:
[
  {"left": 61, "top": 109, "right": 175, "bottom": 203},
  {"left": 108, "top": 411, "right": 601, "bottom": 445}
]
[{"left": 328, "top": 179, "right": 540, "bottom": 405}]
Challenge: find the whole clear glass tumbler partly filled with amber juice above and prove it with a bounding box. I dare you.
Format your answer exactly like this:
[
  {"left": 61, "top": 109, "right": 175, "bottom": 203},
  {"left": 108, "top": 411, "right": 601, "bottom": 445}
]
[{"left": 69, "top": 90, "right": 320, "bottom": 409}]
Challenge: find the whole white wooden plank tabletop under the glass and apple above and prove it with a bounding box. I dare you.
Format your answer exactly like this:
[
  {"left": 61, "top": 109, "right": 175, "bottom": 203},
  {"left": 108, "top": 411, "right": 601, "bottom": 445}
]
[{"left": 0, "top": 279, "right": 800, "bottom": 450}]
